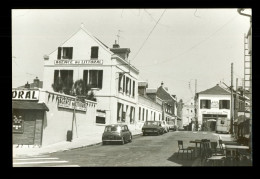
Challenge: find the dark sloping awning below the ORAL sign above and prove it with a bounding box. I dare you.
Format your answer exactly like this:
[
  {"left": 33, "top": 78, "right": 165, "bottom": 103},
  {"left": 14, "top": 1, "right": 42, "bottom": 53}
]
[{"left": 12, "top": 101, "right": 49, "bottom": 111}]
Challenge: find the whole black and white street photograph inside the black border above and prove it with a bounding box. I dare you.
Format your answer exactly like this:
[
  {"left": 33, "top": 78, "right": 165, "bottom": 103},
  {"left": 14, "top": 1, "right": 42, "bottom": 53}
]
[{"left": 11, "top": 8, "right": 253, "bottom": 167}]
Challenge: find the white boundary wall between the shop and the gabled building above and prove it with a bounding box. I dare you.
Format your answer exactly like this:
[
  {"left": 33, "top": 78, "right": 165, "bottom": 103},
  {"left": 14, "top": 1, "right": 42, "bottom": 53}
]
[{"left": 39, "top": 90, "right": 96, "bottom": 145}]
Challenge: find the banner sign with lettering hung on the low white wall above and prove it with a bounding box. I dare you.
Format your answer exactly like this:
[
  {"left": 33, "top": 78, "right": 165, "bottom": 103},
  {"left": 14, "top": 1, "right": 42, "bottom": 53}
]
[{"left": 58, "top": 97, "right": 87, "bottom": 111}]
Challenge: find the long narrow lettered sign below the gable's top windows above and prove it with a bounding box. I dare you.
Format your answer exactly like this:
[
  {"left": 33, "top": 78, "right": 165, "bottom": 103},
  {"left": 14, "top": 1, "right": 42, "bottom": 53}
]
[{"left": 54, "top": 60, "right": 103, "bottom": 65}]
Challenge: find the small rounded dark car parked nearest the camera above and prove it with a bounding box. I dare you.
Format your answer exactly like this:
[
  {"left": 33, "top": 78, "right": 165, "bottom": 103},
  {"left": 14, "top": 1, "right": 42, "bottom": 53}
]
[{"left": 102, "top": 124, "right": 132, "bottom": 145}]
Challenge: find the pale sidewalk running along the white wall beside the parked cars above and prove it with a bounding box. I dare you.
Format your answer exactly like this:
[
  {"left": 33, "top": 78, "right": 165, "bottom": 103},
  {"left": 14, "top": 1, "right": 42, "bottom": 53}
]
[{"left": 13, "top": 129, "right": 142, "bottom": 158}]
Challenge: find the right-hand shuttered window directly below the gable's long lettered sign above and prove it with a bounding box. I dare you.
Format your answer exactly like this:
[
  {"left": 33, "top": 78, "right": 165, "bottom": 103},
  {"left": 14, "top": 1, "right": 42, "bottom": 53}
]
[{"left": 83, "top": 70, "right": 103, "bottom": 89}]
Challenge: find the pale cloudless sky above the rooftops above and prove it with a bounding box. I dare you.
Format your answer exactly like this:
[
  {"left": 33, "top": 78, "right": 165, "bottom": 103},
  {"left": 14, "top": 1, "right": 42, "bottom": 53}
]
[{"left": 12, "top": 8, "right": 251, "bottom": 102}]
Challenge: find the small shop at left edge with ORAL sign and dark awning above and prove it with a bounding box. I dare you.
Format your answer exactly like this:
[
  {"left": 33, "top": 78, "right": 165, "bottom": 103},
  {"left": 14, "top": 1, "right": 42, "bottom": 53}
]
[{"left": 12, "top": 89, "right": 49, "bottom": 145}]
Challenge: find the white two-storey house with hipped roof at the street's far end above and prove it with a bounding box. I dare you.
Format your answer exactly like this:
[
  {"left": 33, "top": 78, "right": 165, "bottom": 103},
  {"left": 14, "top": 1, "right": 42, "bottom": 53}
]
[{"left": 196, "top": 84, "right": 231, "bottom": 131}]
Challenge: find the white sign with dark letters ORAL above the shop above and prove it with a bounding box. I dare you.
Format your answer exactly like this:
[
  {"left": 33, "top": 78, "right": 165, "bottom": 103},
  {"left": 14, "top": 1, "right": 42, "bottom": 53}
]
[{"left": 12, "top": 89, "right": 39, "bottom": 100}]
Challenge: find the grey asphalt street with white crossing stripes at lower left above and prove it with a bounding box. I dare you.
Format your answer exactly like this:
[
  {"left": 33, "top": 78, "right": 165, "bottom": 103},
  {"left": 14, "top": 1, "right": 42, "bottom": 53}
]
[{"left": 13, "top": 131, "right": 218, "bottom": 167}]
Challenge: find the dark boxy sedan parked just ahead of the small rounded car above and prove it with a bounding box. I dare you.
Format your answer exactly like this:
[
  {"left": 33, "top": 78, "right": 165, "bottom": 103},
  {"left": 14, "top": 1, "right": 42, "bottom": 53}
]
[{"left": 142, "top": 121, "right": 164, "bottom": 135}]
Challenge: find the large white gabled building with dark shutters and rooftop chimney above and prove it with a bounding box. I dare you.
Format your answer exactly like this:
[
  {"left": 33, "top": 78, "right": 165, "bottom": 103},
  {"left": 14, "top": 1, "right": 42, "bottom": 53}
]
[{"left": 43, "top": 25, "right": 139, "bottom": 129}]
